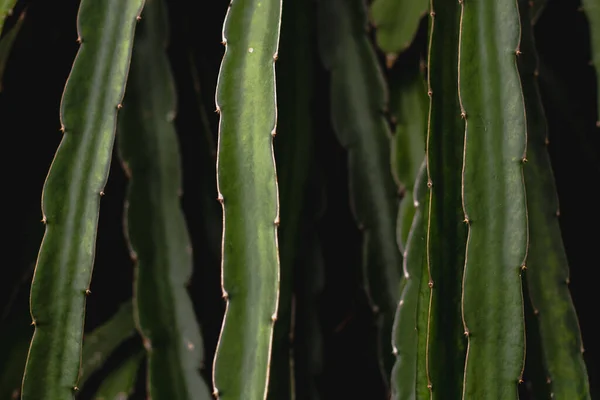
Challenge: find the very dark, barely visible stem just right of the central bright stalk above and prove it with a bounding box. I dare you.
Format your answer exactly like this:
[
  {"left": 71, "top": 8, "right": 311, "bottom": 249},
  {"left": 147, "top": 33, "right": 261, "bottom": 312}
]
[{"left": 268, "top": 0, "right": 316, "bottom": 400}]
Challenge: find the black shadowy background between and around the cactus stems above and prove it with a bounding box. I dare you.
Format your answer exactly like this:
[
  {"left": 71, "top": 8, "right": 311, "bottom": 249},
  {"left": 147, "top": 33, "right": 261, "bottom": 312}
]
[{"left": 0, "top": 0, "right": 600, "bottom": 400}]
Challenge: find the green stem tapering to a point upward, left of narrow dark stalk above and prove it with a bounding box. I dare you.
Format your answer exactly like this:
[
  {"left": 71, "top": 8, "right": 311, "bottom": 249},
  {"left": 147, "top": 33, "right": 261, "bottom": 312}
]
[{"left": 391, "top": 161, "right": 430, "bottom": 400}]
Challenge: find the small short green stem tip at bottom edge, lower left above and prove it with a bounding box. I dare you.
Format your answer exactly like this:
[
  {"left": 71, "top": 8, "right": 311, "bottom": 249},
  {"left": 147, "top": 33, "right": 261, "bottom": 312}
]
[{"left": 94, "top": 350, "right": 150, "bottom": 400}]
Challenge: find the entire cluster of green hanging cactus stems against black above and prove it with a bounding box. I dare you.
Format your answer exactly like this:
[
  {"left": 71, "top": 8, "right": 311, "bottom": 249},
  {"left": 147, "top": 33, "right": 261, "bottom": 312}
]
[{"left": 0, "top": 0, "right": 600, "bottom": 400}]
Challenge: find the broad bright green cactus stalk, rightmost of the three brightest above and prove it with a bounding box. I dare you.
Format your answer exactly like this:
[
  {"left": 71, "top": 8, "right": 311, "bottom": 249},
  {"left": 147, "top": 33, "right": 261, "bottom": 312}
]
[{"left": 458, "top": 0, "right": 528, "bottom": 399}]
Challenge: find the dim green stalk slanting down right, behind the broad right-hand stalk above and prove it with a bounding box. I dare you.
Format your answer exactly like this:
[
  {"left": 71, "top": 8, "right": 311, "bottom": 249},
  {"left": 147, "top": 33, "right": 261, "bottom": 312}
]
[{"left": 519, "top": 0, "right": 590, "bottom": 399}]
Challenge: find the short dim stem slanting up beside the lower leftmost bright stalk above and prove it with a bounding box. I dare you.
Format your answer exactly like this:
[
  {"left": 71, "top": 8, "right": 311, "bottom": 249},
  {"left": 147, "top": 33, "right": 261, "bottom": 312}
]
[{"left": 79, "top": 301, "right": 136, "bottom": 389}]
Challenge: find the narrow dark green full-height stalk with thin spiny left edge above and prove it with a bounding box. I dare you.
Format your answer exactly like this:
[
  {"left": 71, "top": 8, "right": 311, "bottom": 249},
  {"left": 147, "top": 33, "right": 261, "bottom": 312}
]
[{"left": 424, "top": 0, "right": 467, "bottom": 398}]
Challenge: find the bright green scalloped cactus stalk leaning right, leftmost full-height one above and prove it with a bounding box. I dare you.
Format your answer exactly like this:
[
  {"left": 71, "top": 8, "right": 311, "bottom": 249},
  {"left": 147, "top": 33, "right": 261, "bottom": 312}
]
[{"left": 22, "top": 0, "right": 144, "bottom": 400}]
